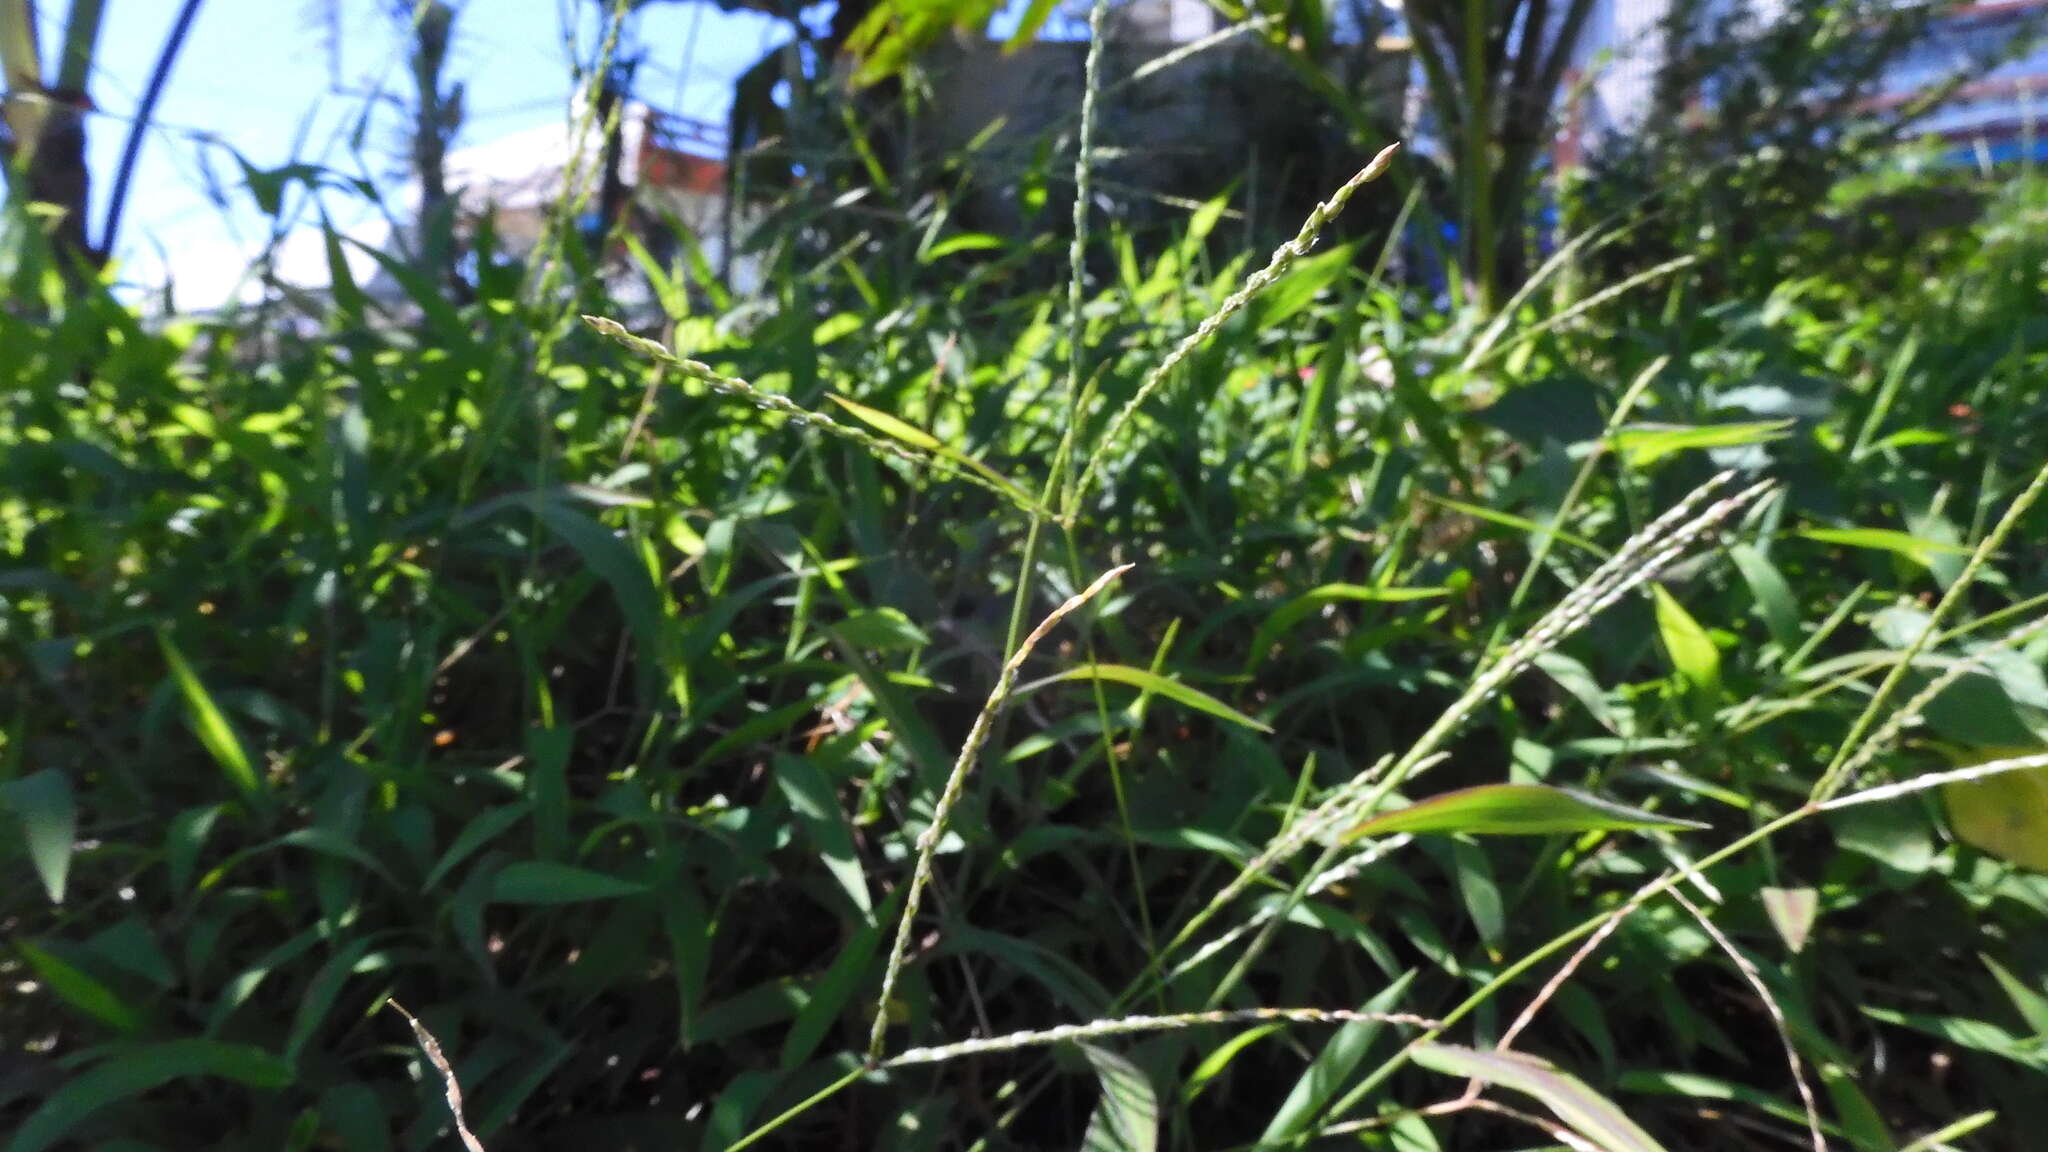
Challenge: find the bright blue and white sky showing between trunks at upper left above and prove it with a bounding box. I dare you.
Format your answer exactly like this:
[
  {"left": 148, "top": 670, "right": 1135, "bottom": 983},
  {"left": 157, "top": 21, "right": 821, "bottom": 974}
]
[{"left": 54, "top": 0, "right": 786, "bottom": 295}]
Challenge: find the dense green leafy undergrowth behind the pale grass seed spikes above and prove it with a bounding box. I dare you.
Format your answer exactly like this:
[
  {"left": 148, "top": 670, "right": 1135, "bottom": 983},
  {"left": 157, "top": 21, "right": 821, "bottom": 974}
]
[{"left": 0, "top": 83, "right": 2048, "bottom": 1152}]
